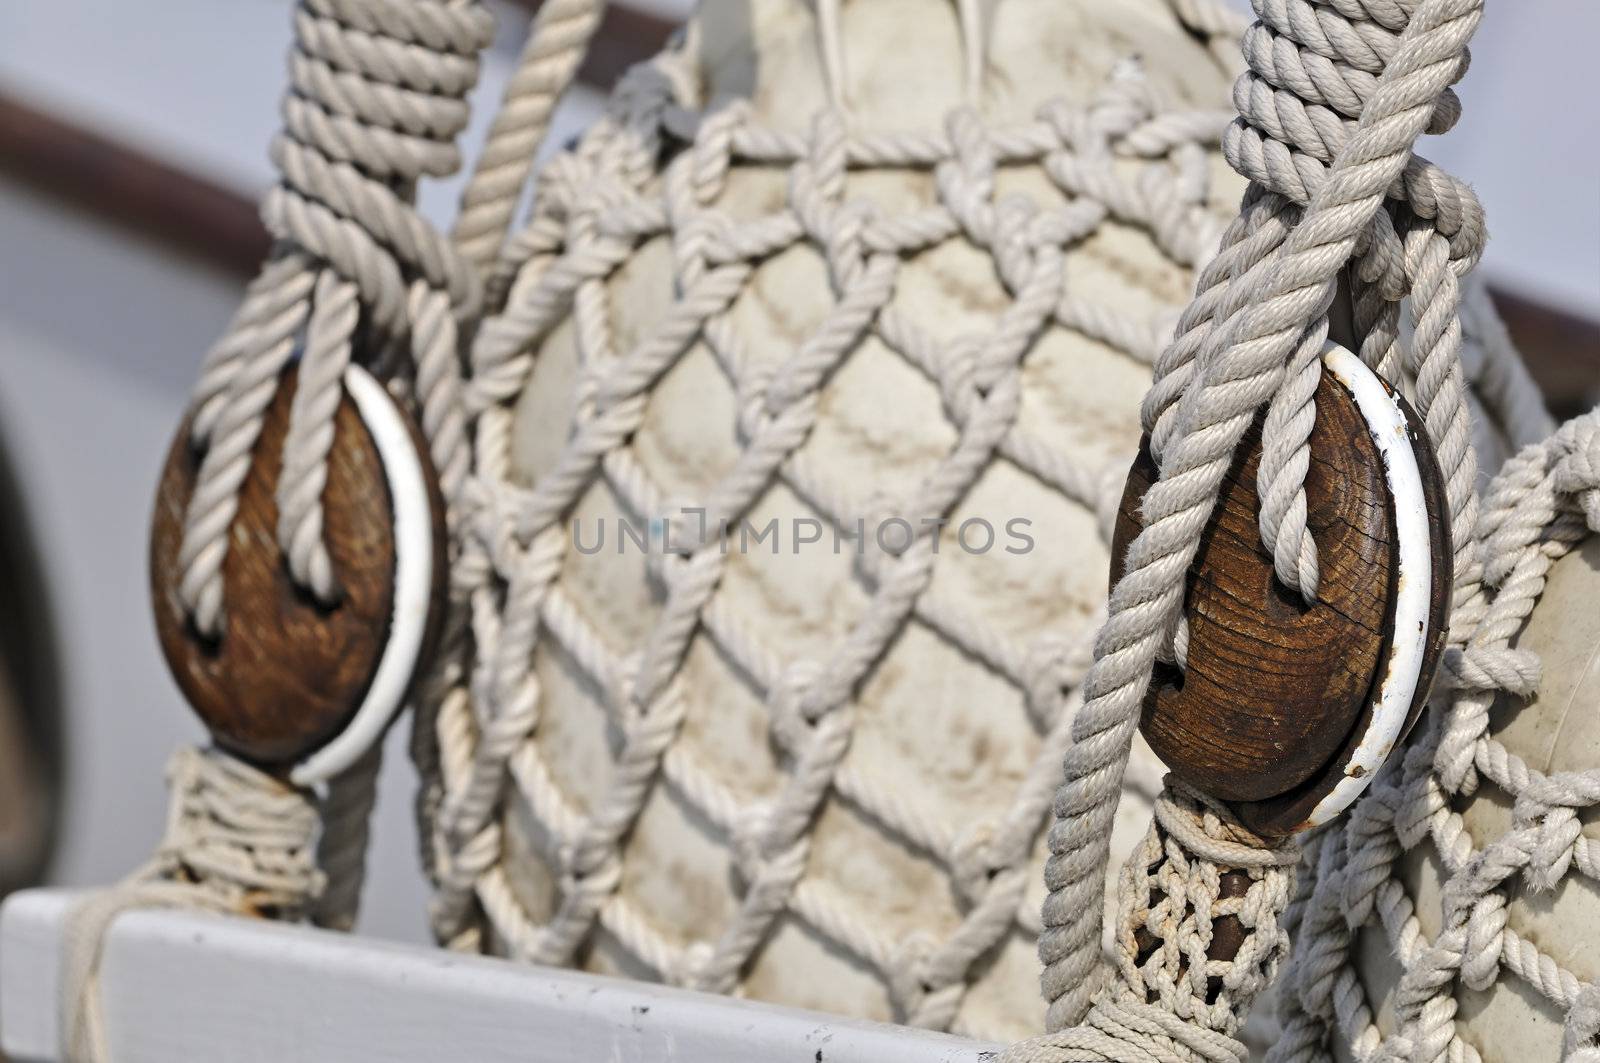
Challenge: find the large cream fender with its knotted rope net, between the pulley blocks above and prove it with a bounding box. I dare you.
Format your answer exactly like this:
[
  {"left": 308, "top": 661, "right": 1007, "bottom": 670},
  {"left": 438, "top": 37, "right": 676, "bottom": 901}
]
[{"left": 419, "top": 3, "right": 1237, "bottom": 1039}]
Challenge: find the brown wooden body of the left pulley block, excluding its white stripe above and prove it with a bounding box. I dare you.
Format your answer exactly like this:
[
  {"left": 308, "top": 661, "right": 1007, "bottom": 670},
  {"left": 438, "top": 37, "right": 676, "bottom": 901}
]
[{"left": 150, "top": 368, "right": 445, "bottom": 768}]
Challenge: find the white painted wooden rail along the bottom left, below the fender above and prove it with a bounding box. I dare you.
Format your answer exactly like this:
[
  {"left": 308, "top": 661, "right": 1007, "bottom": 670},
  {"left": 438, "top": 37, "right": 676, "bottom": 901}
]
[{"left": 0, "top": 890, "right": 995, "bottom": 1063}]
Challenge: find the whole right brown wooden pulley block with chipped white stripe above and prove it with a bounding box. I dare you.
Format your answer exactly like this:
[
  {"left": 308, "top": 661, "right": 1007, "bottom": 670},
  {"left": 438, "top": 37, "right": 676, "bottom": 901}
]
[{"left": 1112, "top": 346, "right": 1453, "bottom": 837}]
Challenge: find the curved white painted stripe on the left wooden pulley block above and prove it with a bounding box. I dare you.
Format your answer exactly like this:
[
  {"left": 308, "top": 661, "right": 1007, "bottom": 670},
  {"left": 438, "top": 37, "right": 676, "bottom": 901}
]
[{"left": 290, "top": 365, "right": 434, "bottom": 786}]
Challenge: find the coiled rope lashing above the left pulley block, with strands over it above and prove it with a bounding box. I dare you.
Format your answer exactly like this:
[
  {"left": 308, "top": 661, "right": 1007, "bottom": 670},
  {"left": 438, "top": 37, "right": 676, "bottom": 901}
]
[{"left": 179, "top": 0, "right": 493, "bottom": 639}]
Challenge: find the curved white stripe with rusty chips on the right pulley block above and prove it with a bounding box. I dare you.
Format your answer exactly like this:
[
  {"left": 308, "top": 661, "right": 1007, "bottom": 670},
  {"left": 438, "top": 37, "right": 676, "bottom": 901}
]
[{"left": 1309, "top": 344, "right": 1434, "bottom": 826}]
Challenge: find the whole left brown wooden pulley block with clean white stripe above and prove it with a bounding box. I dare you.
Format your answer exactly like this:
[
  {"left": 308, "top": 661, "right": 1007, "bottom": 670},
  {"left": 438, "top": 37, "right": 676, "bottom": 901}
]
[{"left": 150, "top": 367, "right": 445, "bottom": 786}]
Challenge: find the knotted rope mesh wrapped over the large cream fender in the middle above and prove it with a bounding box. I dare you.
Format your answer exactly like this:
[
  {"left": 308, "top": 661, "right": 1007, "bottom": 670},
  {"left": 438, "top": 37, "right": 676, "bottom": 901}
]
[{"left": 416, "top": 5, "right": 1248, "bottom": 1028}]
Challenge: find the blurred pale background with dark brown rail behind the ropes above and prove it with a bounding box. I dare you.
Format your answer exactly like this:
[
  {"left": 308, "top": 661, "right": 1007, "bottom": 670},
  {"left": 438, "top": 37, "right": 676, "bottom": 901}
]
[{"left": 0, "top": 0, "right": 1600, "bottom": 941}]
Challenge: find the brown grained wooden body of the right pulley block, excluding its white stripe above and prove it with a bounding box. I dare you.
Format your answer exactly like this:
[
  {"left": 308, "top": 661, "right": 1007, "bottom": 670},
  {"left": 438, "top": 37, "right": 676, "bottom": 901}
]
[{"left": 1110, "top": 371, "right": 1451, "bottom": 837}]
